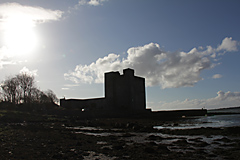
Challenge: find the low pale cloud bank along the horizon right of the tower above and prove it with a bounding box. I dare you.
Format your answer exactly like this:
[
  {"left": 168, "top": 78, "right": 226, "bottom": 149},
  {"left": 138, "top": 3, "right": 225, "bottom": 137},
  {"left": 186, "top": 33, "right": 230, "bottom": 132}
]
[{"left": 147, "top": 91, "right": 240, "bottom": 111}]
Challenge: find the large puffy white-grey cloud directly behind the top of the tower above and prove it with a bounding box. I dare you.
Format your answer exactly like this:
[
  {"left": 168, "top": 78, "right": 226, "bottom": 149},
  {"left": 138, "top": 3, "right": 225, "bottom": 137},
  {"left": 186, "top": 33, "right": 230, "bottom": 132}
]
[{"left": 64, "top": 38, "right": 239, "bottom": 88}]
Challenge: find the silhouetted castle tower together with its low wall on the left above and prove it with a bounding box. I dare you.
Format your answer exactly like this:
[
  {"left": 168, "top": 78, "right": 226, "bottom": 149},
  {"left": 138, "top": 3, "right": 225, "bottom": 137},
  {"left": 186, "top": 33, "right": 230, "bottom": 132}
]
[{"left": 60, "top": 68, "right": 147, "bottom": 115}]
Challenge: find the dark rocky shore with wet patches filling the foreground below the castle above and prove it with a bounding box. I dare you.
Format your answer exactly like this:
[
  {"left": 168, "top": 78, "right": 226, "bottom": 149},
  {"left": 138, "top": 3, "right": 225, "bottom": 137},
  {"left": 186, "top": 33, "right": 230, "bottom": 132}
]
[{"left": 0, "top": 105, "right": 240, "bottom": 160}]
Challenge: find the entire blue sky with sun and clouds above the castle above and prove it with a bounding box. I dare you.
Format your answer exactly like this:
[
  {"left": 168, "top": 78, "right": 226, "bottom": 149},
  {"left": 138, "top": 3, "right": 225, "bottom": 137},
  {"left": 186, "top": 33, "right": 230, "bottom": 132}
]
[{"left": 0, "top": 0, "right": 240, "bottom": 110}]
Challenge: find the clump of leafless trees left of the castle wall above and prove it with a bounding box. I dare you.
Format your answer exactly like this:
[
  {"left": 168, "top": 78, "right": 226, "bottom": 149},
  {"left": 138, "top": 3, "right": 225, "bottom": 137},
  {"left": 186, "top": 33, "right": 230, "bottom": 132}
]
[{"left": 0, "top": 73, "right": 58, "bottom": 104}]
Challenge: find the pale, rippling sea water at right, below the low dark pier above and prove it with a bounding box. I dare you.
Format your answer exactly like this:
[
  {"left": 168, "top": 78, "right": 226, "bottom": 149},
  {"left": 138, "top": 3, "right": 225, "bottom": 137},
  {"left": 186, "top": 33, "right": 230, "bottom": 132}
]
[{"left": 154, "top": 114, "right": 240, "bottom": 129}]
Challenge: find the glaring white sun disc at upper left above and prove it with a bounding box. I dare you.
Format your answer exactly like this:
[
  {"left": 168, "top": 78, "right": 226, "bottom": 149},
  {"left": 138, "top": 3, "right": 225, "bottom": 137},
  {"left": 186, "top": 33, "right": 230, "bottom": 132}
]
[{"left": 4, "top": 17, "right": 38, "bottom": 55}]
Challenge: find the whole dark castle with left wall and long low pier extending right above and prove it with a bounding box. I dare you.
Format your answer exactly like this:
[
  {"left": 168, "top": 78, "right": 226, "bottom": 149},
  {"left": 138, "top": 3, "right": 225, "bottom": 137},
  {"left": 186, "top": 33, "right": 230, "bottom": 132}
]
[{"left": 60, "top": 68, "right": 207, "bottom": 118}]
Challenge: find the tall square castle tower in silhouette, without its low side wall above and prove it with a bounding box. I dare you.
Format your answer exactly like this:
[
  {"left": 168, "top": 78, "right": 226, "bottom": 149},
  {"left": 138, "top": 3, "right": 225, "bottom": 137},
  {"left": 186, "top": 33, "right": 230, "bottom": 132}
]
[{"left": 105, "top": 68, "right": 146, "bottom": 112}]
